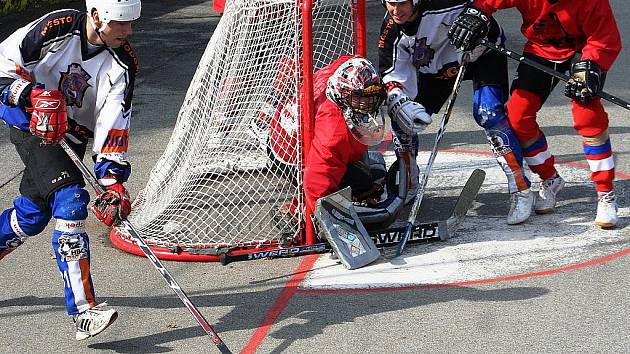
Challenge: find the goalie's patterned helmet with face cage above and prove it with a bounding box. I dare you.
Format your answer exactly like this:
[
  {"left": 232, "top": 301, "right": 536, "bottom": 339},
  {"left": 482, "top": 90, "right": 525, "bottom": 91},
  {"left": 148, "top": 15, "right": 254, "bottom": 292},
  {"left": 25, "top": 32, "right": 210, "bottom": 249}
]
[{"left": 326, "top": 57, "right": 385, "bottom": 146}]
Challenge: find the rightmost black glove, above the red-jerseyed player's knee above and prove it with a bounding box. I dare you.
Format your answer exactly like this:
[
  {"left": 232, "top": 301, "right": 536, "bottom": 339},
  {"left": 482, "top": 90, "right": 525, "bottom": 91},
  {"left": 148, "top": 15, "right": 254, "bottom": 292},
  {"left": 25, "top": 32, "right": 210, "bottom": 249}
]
[{"left": 564, "top": 60, "right": 602, "bottom": 103}]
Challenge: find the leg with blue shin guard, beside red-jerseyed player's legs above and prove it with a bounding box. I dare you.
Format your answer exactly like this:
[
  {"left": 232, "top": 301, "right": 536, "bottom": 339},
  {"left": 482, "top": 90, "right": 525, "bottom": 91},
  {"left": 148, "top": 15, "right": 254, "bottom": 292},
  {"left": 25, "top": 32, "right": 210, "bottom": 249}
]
[{"left": 471, "top": 52, "right": 534, "bottom": 225}]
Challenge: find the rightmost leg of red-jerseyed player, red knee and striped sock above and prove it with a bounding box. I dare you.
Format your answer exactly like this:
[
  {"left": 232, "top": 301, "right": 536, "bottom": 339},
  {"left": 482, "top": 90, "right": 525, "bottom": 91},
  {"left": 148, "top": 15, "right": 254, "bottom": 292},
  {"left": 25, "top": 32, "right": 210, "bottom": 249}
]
[{"left": 572, "top": 97, "right": 618, "bottom": 228}]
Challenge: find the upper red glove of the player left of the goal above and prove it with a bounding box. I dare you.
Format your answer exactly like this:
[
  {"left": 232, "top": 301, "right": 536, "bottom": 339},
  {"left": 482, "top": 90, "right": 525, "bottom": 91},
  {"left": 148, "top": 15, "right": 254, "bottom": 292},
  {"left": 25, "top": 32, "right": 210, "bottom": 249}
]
[{"left": 26, "top": 88, "right": 68, "bottom": 145}]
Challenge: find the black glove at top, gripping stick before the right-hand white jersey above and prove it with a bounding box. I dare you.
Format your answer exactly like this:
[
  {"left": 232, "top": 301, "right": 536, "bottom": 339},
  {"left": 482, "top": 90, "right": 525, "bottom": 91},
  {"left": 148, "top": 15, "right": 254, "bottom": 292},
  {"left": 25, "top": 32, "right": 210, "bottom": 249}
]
[{"left": 448, "top": 7, "right": 490, "bottom": 51}]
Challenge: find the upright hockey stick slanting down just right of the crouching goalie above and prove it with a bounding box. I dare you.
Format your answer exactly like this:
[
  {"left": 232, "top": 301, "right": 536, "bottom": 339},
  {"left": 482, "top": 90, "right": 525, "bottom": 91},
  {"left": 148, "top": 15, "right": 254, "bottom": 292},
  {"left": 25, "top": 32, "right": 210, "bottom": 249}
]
[{"left": 395, "top": 52, "right": 470, "bottom": 257}]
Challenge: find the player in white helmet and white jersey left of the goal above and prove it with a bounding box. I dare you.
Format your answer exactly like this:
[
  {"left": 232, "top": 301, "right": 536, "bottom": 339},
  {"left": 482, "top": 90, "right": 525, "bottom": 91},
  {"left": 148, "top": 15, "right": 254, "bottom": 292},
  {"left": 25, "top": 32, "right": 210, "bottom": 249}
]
[{"left": 0, "top": 0, "right": 141, "bottom": 340}]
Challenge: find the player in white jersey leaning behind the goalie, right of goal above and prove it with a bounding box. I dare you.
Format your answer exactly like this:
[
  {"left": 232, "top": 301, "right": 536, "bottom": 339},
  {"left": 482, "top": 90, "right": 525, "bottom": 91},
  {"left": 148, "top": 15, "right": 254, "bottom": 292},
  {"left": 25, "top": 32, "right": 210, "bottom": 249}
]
[{"left": 378, "top": 0, "right": 534, "bottom": 224}]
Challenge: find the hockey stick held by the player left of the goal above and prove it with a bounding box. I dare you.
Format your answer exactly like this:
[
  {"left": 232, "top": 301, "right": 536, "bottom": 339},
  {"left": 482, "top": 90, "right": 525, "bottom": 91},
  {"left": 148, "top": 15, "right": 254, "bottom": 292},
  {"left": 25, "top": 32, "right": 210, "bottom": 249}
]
[{"left": 59, "top": 140, "right": 232, "bottom": 354}]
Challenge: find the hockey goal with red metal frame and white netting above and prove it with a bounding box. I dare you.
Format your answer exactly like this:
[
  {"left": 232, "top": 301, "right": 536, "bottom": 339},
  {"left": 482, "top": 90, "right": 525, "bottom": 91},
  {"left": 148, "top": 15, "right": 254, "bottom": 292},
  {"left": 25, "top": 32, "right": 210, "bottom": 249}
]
[{"left": 110, "top": 0, "right": 366, "bottom": 261}]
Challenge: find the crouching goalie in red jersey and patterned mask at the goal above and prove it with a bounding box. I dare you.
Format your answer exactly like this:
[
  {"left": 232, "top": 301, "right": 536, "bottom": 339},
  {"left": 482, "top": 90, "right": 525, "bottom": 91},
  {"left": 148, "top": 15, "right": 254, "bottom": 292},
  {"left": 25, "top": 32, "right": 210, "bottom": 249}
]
[{"left": 261, "top": 55, "right": 422, "bottom": 269}]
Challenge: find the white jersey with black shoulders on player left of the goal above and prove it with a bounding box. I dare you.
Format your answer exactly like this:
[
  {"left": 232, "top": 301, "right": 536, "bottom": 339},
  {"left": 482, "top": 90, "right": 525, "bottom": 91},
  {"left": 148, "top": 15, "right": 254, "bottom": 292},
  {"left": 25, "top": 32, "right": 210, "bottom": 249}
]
[{"left": 0, "top": 10, "right": 138, "bottom": 174}]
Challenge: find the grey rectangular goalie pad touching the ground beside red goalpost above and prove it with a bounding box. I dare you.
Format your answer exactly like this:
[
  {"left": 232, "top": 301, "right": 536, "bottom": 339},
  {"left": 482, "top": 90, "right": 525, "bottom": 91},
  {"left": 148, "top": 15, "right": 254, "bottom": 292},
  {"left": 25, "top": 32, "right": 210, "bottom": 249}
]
[{"left": 315, "top": 188, "right": 380, "bottom": 269}]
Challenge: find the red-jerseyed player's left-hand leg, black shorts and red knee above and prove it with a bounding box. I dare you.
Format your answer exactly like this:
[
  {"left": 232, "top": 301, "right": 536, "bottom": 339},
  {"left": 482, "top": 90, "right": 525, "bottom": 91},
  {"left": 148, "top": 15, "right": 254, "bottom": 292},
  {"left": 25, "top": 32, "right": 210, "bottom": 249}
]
[{"left": 507, "top": 54, "right": 570, "bottom": 214}]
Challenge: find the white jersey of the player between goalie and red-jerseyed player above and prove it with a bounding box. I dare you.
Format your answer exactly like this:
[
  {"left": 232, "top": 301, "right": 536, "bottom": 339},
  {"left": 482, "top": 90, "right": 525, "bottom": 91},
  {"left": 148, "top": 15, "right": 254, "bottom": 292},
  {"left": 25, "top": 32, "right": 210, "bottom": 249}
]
[{"left": 378, "top": 0, "right": 505, "bottom": 98}]
